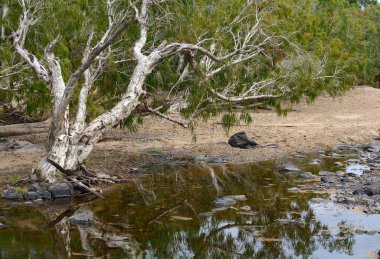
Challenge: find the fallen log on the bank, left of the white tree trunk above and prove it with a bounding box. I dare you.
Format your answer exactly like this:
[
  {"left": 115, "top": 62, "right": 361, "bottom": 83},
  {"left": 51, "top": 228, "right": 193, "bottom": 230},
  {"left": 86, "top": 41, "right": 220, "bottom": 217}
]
[{"left": 0, "top": 119, "right": 51, "bottom": 137}]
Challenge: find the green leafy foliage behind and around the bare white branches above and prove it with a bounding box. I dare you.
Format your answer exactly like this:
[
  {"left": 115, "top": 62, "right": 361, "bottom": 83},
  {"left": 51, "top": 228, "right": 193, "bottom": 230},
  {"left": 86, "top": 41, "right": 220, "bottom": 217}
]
[{"left": 0, "top": 0, "right": 380, "bottom": 130}]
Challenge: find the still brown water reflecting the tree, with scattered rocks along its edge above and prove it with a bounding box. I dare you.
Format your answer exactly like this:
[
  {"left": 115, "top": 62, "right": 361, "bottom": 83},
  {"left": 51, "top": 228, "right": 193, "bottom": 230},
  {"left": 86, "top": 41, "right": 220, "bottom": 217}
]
[{"left": 0, "top": 153, "right": 380, "bottom": 258}]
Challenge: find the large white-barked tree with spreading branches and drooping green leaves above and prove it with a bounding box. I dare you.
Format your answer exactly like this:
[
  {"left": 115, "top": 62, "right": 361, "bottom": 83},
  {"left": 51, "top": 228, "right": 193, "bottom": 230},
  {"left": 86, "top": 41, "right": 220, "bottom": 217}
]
[{"left": 1, "top": 0, "right": 360, "bottom": 191}]
